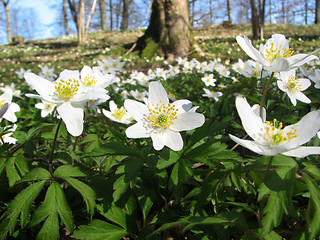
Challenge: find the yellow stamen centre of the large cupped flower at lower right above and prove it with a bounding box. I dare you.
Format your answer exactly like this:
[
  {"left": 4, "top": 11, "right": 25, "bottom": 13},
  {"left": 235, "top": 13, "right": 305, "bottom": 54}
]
[{"left": 264, "top": 119, "right": 297, "bottom": 147}]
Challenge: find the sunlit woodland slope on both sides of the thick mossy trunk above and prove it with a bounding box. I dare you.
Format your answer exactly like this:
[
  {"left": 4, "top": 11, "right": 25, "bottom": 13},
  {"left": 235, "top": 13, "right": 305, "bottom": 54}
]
[{"left": 0, "top": 24, "right": 320, "bottom": 82}]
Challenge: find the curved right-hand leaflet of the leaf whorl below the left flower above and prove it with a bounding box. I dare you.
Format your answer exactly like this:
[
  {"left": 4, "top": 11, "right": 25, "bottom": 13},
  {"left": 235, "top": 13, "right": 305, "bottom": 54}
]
[{"left": 64, "top": 177, "right": 96, "bottom": 217}]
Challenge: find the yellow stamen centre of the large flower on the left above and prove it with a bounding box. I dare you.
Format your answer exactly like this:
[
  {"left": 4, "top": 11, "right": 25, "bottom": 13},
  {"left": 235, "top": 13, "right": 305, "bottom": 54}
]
[{"left": 54, "top": 79, "right": 80, "bottom": 101}]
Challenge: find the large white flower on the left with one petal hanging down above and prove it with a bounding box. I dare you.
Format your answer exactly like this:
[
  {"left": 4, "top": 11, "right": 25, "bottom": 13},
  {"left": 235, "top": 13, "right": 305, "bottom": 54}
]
[{"left": 24, "top": 70, "right": 106, "bottom": 136}]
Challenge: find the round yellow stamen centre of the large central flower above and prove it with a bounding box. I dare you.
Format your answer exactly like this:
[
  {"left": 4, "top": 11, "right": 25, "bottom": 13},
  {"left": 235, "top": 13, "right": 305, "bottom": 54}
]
[{"left": 147, "top": 102, "right": 178, "bottom": 128}]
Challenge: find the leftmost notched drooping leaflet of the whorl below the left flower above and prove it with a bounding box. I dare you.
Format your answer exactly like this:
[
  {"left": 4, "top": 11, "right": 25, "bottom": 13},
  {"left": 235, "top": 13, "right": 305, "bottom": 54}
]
[{"left": 4, "top": 180, "right": 46, "bottom": 235}]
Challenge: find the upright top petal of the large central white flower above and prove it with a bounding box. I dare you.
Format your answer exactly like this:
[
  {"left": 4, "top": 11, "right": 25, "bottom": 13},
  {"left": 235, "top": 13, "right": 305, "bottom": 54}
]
[{"left": 148, "top": 81, "right": 169, "bottom": 106}]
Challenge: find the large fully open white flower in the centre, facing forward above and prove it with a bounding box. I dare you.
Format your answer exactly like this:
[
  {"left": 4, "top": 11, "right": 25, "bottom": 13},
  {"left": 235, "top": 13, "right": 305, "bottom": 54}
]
[{"left": 124, "top": 81, "right": 205, "bottom": 151}]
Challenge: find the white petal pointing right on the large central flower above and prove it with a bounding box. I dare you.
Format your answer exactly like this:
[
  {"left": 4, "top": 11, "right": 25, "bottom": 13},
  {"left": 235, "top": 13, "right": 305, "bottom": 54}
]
[{"left": 169, "top": 112, "right": 205, "bottom": 131}]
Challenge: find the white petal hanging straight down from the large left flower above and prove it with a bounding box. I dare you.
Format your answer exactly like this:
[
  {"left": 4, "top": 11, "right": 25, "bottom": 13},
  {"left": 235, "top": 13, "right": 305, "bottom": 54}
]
[{"left": 57, "top": 102, "right": 83, "bottom": 137}]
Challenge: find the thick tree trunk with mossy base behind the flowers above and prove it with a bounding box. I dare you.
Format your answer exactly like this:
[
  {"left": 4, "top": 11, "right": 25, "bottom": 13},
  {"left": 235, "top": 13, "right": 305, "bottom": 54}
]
[{"left": 136, "top": 0, "right": 194, "bottom": 61}]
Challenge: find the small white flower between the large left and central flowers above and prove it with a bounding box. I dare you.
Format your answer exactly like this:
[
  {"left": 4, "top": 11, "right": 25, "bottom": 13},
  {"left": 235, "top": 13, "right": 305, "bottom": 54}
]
[{"left": 102, "top": 101, "right": 132, "bottom": 124}]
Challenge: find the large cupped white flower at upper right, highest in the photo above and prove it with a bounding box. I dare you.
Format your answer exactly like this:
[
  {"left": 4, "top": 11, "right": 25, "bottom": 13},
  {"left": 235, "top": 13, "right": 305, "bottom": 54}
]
[{"left": 236, "top": 34, "right": 320, "bottom": 72}]
